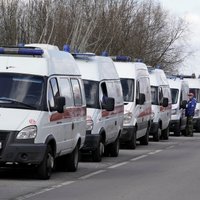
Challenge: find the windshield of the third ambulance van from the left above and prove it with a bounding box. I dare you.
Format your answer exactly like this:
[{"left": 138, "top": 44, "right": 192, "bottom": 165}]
[{"left": 121, "top": 78, "right": 134, "bottom": 102}]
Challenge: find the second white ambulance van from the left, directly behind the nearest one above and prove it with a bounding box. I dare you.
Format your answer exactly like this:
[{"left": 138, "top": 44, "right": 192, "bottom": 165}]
[{"left": 74, "top": 53, "right": 124, "bottom": 162}]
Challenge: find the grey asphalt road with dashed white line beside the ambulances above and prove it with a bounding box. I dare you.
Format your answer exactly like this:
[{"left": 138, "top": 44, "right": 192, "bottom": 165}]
[{"left": 0, "top": 133, "right": 200, "bottom": 200}]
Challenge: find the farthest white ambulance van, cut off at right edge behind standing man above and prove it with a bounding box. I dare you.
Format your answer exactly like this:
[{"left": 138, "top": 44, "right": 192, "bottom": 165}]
[{"left": 180, "top": 74, "right": 200, "bottom": 132}]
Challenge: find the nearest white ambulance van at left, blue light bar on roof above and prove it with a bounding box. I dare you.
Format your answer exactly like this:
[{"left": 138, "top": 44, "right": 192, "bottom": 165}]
[{"left": 0, "top": 44, "right": 86, "bottom": 179}]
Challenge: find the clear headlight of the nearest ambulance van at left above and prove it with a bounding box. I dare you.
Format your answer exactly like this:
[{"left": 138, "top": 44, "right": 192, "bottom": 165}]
[{"left": 17, "top": 126, "right": 37, "bottom": 139}]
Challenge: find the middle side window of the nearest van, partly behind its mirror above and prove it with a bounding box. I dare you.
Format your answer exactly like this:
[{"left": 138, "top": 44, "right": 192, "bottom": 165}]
[{"left": 59, "top": 77, "right": 74, "bottom": 107}]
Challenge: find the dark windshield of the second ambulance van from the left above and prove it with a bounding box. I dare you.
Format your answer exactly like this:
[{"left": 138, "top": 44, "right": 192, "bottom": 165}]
[{"left": 83, "top": 80, "right": 100, "bottom": 108}]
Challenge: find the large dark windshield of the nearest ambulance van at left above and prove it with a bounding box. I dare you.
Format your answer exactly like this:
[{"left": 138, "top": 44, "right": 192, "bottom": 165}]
[{"left": 0, "top": 73, "right": 44, "bottom": 110}]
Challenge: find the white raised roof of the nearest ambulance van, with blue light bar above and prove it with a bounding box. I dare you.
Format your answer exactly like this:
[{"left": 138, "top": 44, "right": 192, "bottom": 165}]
[{"left": 0, "top": 44, "right": 80, "bottom": 76}]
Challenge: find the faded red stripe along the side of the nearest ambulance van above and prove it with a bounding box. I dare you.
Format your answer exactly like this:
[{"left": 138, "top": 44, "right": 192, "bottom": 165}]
[{"left": 50, "top": 107, "right": 86, "bottom": 121}]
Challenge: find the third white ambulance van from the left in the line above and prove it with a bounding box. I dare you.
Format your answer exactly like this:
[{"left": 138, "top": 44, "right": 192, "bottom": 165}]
[{"left": 113, "top": 56, "right": 151, "bottom": 149}]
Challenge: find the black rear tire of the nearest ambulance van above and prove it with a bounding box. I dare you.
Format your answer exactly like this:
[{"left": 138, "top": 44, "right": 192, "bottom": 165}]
[{"left": 67, "top": 145, "right": 79, "bottom": 172}]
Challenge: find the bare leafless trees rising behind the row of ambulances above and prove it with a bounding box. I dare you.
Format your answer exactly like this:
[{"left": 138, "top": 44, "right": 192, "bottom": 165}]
[{"left": 0, "top": 0, "right": 187, "bottom": 70}]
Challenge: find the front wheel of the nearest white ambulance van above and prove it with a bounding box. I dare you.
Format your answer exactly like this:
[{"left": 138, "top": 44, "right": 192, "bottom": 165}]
[{"left": 37, "top": 145, "right": 54, "bottom": 180}]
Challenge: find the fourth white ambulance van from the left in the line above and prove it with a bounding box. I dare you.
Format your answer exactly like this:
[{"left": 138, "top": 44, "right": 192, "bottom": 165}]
[{"left": 148, "top": 67, "right": 172, "bottom": 141}]
